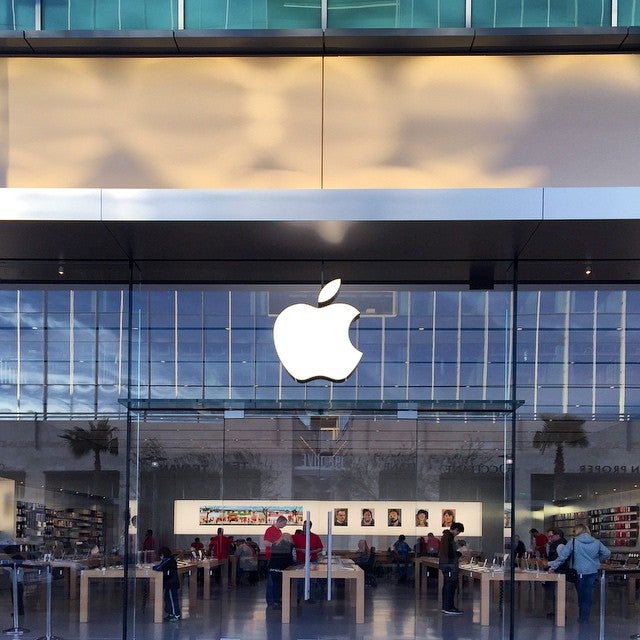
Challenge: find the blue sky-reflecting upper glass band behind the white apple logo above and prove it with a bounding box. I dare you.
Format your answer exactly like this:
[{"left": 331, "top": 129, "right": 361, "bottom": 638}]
[{"left": 0, "top": 285, "right": 640, "bottom": 419}]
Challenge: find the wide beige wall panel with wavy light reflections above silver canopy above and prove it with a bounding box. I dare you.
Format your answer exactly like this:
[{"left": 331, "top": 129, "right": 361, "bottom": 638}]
[{"left": 0, "top": 53, "right": 640, "bottom": 190}]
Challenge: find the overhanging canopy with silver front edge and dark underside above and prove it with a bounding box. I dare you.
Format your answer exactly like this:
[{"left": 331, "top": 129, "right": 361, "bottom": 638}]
[{"left": 0, "top": 187, "right": 640, "bottom": 288}]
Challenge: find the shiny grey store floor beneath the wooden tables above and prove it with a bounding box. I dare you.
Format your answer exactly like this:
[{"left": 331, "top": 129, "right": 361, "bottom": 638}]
[{"left": 0, "top": 577, "right": 640, "bottom": 640}]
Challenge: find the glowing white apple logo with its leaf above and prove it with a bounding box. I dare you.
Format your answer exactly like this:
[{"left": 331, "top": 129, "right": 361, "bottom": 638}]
[{"left": 273, "top": 279, "right": 362, "bottom": 382}]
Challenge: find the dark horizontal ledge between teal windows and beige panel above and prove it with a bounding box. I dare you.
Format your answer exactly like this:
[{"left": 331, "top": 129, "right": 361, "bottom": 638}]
[{"left": 0, "top": 27, "right": 640, "bottom": 56}]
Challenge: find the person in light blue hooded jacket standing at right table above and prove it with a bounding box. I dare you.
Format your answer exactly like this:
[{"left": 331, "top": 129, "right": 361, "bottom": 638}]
[{"left": 549, "top": 524, "right": 611, "bottom": 624}]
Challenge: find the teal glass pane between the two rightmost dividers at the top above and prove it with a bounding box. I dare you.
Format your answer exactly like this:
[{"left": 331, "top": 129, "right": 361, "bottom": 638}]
[{"left": 471, "top": 0, "right": 611, "bottom": 28}]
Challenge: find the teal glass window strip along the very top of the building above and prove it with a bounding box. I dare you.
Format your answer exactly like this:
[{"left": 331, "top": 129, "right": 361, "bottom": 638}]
[{"left": 0, "top": 0, "right": 640, "bottom": 31}]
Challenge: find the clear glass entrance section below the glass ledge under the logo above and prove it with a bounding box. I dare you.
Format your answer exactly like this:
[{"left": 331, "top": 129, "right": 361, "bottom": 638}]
[{"left": 129, "top": 411, "right": 511, "bottom": 639}]
